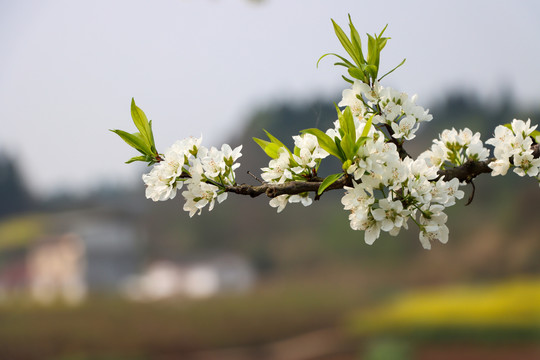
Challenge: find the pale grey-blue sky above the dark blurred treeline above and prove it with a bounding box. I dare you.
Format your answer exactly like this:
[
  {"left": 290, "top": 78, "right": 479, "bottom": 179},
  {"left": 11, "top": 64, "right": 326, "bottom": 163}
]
[{"left": 0, "top": 0, "right": 540, "bottom": 197}]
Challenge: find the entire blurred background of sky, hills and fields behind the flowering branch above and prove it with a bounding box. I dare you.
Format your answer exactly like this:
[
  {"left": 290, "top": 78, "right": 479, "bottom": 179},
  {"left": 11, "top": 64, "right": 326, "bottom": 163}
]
[{"left": 0, "top": 0, "right": 540, "bottom": 360}]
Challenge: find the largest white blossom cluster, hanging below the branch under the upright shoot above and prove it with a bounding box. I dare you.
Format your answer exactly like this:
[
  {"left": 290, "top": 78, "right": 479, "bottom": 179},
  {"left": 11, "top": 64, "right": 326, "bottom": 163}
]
[{"left": 334, "top": 122, "right": 464, "bottom": 249}]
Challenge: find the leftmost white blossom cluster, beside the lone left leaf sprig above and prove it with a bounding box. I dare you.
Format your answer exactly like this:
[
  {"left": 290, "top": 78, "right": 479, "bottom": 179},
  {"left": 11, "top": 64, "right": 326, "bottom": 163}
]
[{"left": 142, "top": 137, "right": 242, "bottom": 216}]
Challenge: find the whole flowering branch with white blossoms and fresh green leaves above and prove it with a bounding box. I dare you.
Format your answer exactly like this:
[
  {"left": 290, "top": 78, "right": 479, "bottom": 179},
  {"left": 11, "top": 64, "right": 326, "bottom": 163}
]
[{"left": 113, "top": 17, "right": 540, "bottom": 249}]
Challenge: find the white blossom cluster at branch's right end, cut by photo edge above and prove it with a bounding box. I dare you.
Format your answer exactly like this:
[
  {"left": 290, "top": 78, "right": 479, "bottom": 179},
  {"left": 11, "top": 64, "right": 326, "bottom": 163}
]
[{"left": 486, "top": 119, "right": 540, "bottom": 181}]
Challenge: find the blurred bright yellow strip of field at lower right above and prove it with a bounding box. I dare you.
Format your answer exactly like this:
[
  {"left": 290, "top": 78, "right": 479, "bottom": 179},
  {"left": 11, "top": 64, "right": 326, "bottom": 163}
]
[{"left": 352, "top": 278, "right": 540, "bottom": 341}]
